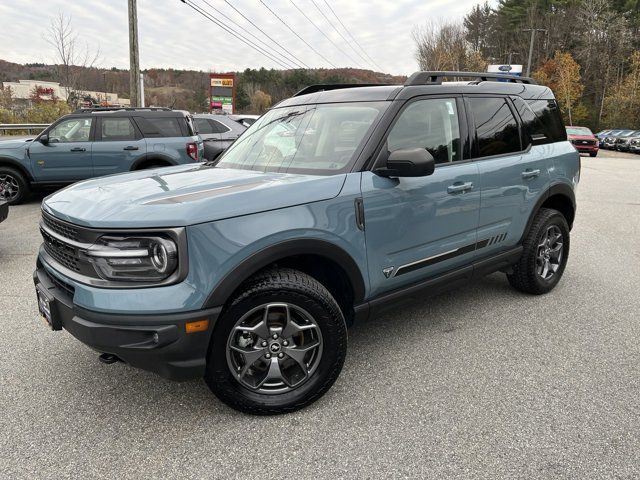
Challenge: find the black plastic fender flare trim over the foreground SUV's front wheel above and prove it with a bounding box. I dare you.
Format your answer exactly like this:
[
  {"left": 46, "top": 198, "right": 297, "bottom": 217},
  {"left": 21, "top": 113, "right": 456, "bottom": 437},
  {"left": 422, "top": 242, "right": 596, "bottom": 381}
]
[{"left": 202, "top": 238, "right": 365, "bottom": 308}]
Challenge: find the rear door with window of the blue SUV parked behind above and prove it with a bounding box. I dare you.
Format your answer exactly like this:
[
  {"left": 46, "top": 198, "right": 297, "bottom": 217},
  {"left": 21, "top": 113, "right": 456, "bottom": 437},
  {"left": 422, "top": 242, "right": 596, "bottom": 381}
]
[{"left": 93, "top": 114, "right": 147, "bottom": 176}]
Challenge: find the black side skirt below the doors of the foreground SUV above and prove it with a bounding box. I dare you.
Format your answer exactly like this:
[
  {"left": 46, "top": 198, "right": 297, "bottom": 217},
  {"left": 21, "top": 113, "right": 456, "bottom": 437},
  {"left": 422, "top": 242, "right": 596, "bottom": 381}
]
[{"left": 354, "top": 245, "right": 522, "bottom": 321}]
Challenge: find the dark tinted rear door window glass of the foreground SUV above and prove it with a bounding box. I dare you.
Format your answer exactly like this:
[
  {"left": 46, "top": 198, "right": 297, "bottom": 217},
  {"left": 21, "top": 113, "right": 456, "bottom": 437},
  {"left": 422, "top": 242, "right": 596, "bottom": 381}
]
[{"left": 469, "top": 97, "right": 522, "bottom": 157}]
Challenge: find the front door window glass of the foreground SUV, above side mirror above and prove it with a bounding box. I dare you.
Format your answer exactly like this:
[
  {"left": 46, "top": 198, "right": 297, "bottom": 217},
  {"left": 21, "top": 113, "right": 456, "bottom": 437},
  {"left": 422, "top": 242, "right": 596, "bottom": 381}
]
[{"left": 387, "top": 98, "right": 462, "bottom": 163}]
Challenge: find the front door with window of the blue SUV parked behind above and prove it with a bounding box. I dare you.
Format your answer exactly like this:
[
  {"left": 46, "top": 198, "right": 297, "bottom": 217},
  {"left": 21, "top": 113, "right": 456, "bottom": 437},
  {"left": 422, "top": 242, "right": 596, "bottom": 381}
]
[{"left": 29, "top": 117, "right": 95, "bottom": 183}]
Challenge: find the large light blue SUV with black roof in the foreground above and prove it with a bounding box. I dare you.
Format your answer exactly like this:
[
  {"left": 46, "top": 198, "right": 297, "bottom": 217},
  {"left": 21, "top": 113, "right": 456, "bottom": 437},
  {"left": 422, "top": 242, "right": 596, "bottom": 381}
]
[{"left": 34, "top": 72, "right": 580, "bottom": 414}]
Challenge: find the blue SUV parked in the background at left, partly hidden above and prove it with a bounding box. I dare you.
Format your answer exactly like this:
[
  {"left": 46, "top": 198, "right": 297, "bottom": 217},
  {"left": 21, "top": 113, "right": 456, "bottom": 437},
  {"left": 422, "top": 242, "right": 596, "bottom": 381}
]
[{"left": 0, "top": 108, "right": 204, "bottom": 205}]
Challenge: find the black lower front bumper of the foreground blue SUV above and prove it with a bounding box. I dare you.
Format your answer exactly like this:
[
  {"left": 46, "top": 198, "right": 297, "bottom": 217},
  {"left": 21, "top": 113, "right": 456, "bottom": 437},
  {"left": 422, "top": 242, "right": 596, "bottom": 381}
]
[{"left": 33, "top": 265, "right": 220, "bottom": 380}]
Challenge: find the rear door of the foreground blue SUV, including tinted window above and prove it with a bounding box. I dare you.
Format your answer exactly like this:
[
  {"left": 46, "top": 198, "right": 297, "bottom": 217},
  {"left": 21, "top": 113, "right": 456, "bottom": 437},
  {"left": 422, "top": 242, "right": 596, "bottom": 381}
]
[{"left": 465, "top": 96, "right": 549, "bottom": 257}]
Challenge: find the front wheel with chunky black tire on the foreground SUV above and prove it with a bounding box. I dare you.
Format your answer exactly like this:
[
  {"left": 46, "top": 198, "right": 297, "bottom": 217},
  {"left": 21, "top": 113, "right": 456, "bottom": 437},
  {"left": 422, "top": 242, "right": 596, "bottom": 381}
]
[{"left": 205, "top": 268, "right": 347, "bottom": 415}]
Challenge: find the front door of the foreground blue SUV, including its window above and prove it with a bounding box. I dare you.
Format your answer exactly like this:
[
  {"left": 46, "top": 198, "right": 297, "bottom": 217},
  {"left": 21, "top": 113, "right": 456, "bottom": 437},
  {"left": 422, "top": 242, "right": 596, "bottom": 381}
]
[{"left": 361, "top": 97, "right": 480, "bottom": 296}]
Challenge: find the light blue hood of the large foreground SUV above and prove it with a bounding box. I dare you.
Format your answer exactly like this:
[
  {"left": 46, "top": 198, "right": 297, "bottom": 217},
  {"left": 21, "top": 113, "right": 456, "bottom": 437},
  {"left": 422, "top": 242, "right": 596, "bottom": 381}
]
[{"left": 42, "top": 164, "right": 346, "bottom": 228}]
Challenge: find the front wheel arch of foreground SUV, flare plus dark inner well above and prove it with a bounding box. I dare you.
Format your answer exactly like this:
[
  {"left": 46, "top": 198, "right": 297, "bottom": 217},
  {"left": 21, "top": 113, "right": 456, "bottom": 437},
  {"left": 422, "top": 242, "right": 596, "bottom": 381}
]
[{"left": 203, "top": 239, "right": 365, "bottom": 316}]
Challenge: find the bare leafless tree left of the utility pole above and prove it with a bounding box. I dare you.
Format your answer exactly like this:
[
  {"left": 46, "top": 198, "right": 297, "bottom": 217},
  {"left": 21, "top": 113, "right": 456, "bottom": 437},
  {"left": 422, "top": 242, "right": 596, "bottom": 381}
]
[{"left": 45, "top": 12, "right": 100, "bottom": 103}]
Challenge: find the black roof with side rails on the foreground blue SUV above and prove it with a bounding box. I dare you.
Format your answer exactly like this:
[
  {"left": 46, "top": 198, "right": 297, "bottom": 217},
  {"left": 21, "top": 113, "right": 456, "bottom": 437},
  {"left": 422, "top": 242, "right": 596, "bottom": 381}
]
[{"left": 277, "top": 72, "right": 554, "bottom": 107}]
